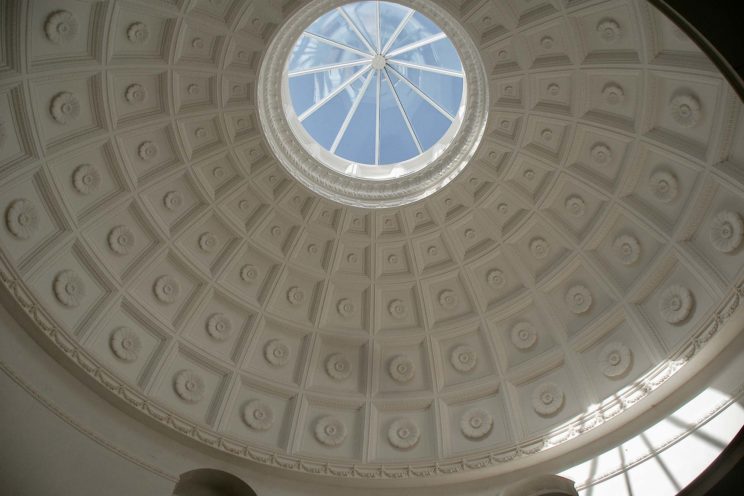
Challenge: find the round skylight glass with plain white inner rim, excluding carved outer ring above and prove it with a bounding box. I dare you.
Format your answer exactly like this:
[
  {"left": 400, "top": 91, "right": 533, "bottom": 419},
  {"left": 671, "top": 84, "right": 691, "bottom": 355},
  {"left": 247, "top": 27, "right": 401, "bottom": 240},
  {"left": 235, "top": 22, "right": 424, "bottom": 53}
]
[{"left": 282, "top": 1, "right": 467, "bottom": 180}]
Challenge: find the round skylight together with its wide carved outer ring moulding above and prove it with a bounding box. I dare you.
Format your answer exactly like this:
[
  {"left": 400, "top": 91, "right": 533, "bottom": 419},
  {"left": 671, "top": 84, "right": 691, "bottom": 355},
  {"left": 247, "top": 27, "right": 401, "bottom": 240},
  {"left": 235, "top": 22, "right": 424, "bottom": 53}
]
[{"left": 258, "top": 0, "right": 489, "bottom": 208}]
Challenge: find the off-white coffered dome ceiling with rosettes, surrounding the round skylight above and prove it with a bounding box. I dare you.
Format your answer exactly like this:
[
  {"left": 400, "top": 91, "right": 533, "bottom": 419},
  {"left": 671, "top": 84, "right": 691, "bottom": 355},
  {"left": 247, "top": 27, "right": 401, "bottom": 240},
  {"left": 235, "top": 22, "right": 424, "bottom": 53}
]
[{"left": 0, "top": 0, "right": 744, "bottom": 479}]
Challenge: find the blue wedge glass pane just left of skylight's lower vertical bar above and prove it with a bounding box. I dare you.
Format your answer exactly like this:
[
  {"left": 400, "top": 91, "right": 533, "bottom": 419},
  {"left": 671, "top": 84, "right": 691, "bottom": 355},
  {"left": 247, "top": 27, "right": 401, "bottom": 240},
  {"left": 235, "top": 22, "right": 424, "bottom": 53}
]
[{"left": 336, "top": 72, "right": 378, "bottom": 164}]
